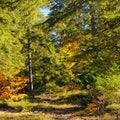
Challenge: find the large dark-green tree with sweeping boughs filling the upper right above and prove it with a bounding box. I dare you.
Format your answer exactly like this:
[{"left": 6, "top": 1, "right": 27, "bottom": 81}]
[{"left": 46, "top": 0, "right": 120, "bottom": 88}]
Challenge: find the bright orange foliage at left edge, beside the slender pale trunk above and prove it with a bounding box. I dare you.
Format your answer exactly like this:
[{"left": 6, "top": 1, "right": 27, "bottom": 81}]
[{"left": 0, "top": 74, "right": 27, "bottom": 100}]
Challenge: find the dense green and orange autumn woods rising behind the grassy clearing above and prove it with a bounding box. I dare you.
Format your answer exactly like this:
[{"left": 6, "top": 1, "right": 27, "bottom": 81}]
[{"left": 0, "top": 0, "right": 120, "bottom": 119}]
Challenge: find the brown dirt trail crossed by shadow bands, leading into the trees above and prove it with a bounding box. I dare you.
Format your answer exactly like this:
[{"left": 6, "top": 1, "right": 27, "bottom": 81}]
[{"left": 33, "top": 95, "right": 80, "bottom": 120}]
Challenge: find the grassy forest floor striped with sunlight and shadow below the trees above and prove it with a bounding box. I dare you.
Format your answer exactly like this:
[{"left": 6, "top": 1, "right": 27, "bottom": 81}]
[{"left": 0, "top": 90, "right": 118, "bottom": 120}]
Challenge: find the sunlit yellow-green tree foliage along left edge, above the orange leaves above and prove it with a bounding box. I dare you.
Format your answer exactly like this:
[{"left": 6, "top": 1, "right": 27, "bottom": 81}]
[{"left": 0, "top": 1, "right": 24, "bottom": 77}]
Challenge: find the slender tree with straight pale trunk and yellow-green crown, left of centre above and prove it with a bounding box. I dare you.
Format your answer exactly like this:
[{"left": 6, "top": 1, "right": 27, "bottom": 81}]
[{"left": 12, "top": 0, "right": 47, "bottom": 95}]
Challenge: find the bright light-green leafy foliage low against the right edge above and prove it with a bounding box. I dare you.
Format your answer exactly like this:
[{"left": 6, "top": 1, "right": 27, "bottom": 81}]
[{"left": 96, "top": 65, "right": 120, "bottom": 103}]
